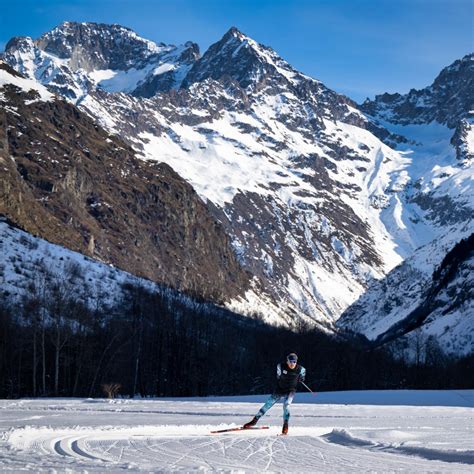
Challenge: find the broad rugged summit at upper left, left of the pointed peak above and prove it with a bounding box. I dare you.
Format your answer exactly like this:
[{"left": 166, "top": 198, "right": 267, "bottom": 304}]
[{"left": 4, "top": 22, "right": 199, "bottom": 101}]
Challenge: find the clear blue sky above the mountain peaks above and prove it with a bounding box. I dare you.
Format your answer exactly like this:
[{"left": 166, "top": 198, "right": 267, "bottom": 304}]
[{"left": 0, "top": 0, "right": 474, "bottom": 101}]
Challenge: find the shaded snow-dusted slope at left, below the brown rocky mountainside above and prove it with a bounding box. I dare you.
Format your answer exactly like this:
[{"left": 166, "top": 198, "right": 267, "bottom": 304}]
[{"left": 0, "top": 217, "right": 258, "bottom": 320}]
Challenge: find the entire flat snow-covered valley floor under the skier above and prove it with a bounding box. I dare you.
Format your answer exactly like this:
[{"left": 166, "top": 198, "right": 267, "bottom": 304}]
[{"left": 0, "top": 390, "right": 474, "bottom": 473}]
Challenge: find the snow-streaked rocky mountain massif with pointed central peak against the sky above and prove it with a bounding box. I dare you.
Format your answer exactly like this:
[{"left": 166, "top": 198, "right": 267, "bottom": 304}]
[{"left": 0, "top": 23, "right": 474, "bottom": 340}]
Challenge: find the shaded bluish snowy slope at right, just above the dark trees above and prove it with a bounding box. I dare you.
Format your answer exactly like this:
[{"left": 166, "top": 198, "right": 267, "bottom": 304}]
[{"left": 337, "top": 224, "right": 474, "bottom": 358}]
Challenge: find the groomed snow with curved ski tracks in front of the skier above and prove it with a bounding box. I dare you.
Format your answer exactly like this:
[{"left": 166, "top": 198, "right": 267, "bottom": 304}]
[{"left": 5, "top": 425, "right": 474, "bottom": 472}]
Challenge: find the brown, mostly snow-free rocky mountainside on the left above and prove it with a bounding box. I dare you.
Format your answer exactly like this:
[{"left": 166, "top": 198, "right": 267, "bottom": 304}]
[{"left": 0, "top": 64, "right": 249, "bottom": 302}]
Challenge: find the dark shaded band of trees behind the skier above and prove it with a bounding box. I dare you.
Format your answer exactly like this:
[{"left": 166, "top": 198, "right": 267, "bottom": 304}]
[{"left": 0, "top": 269, "right": 474, "bottom": 398}]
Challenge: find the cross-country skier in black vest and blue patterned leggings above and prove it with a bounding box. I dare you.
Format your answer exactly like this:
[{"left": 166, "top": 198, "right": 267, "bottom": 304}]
[{"left": 243, "top": 352, "right": 306, "bottom": 434}]
